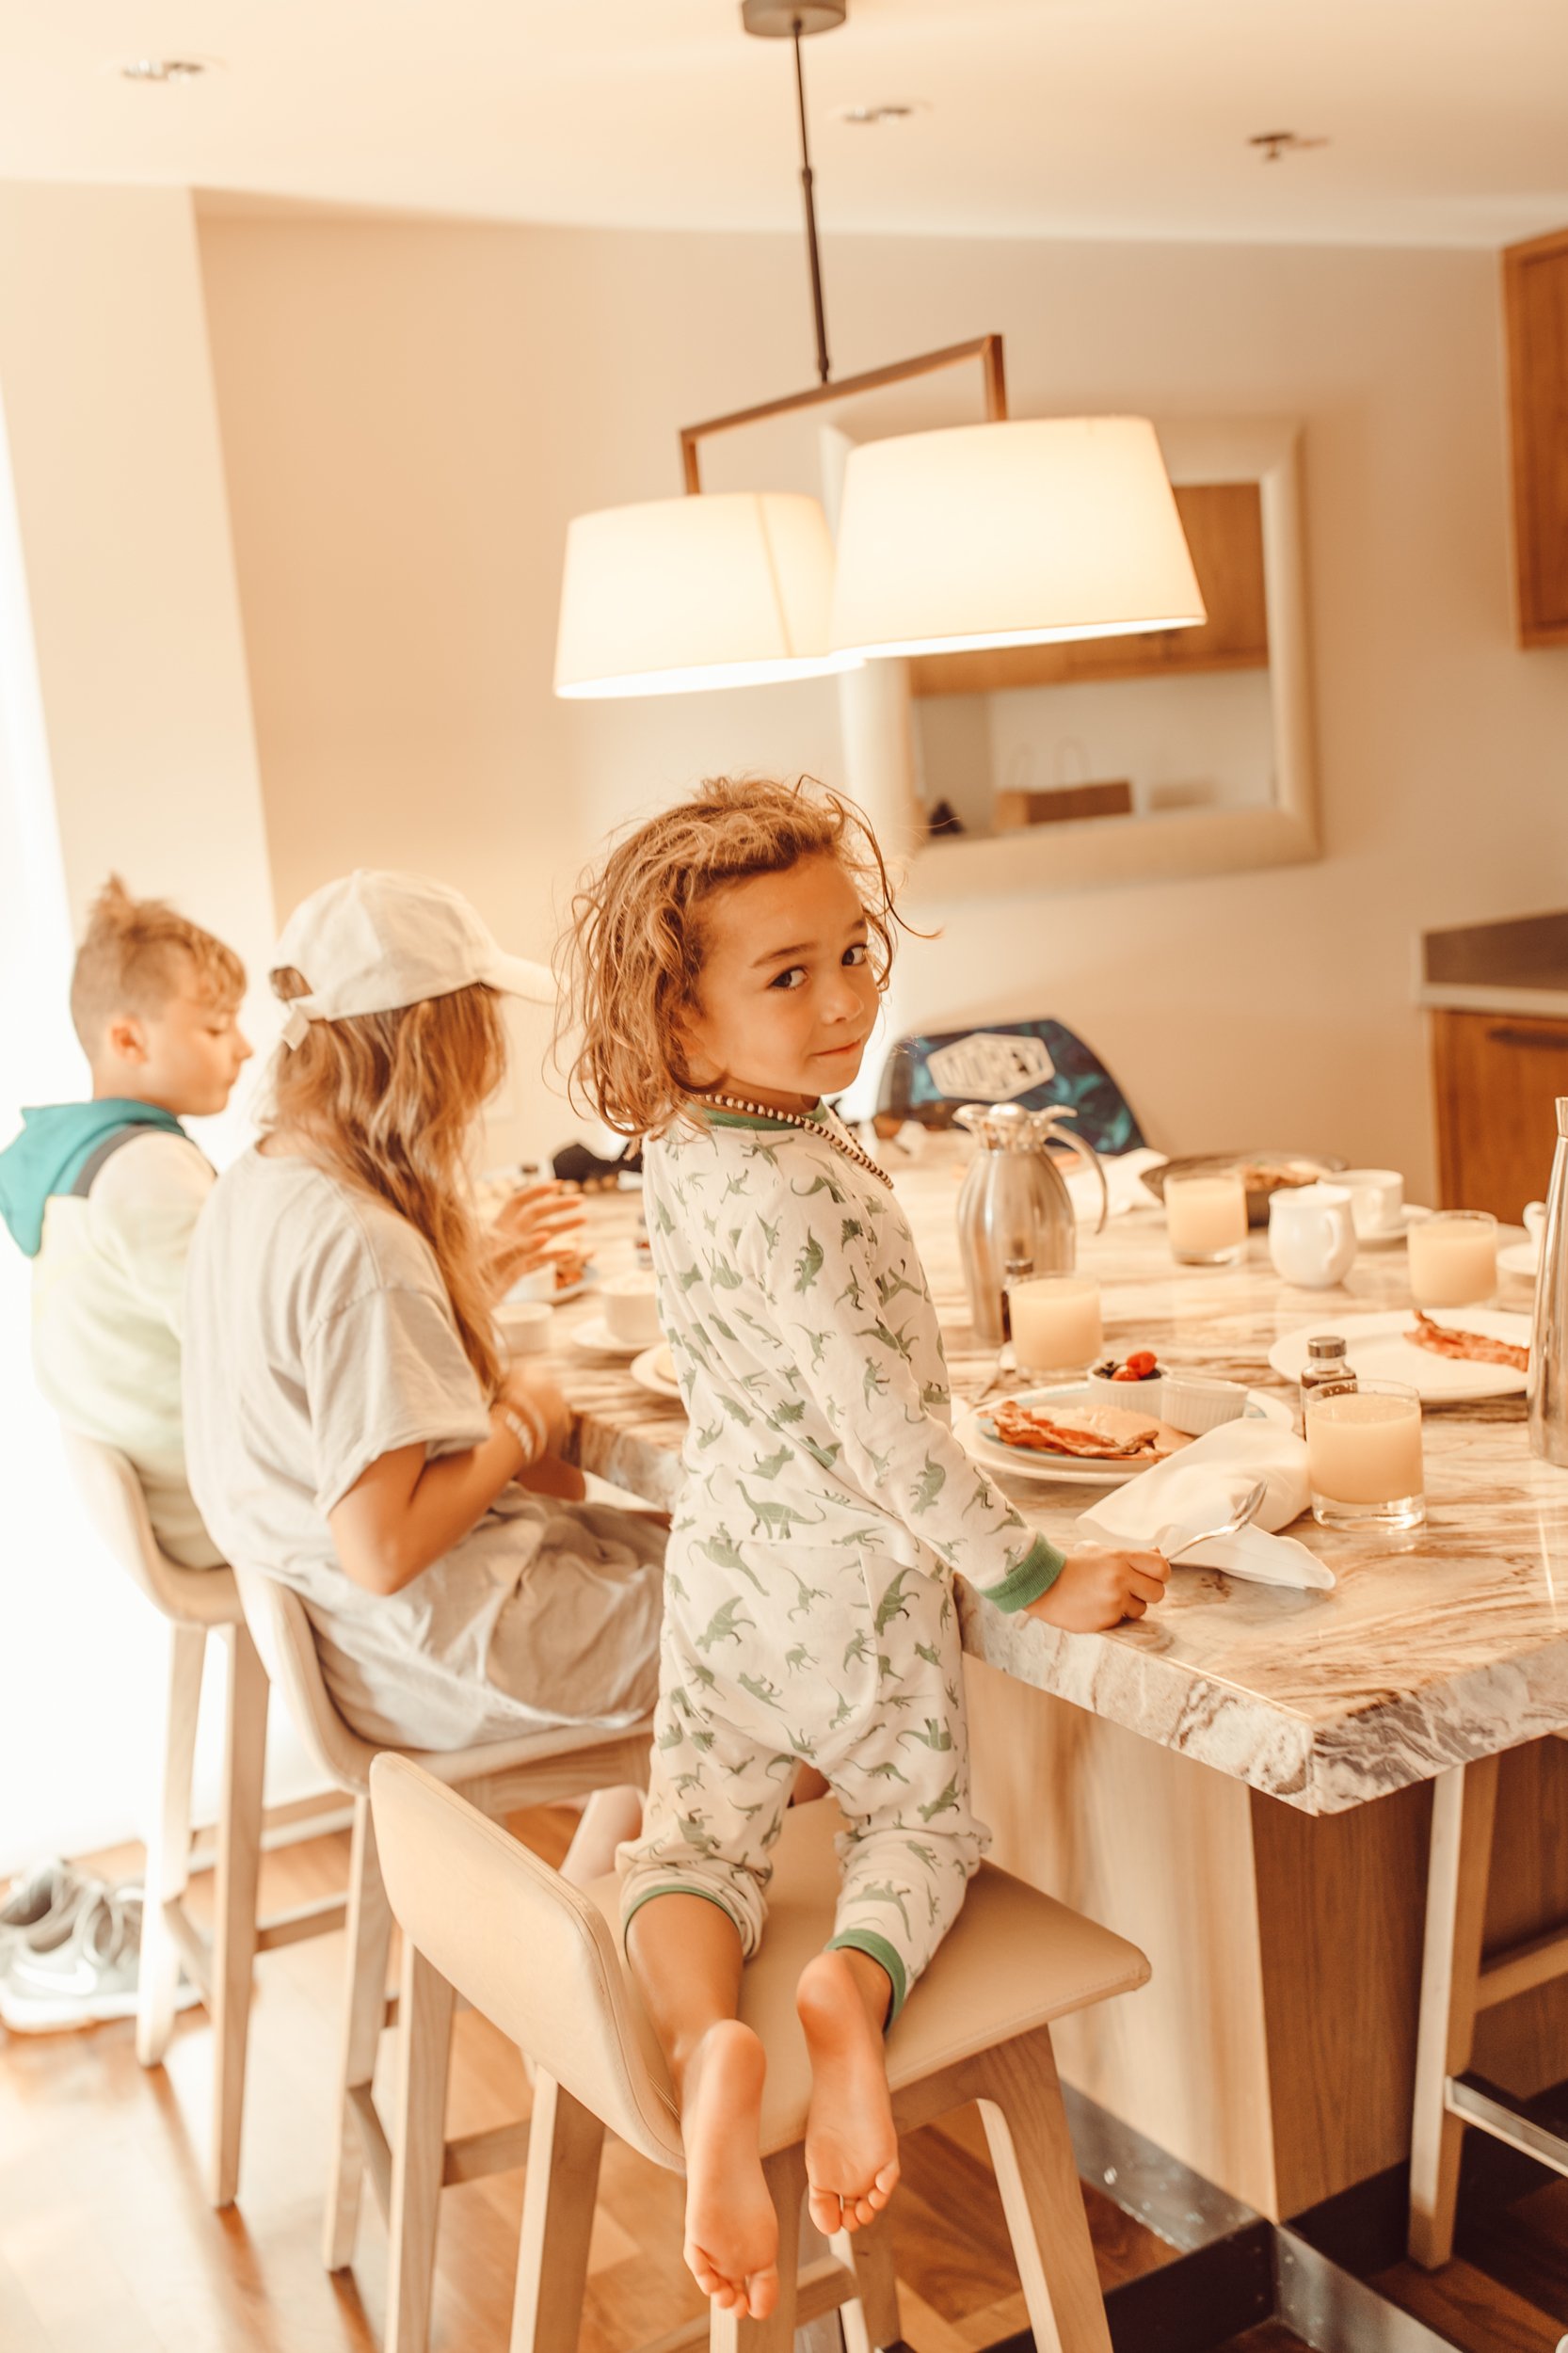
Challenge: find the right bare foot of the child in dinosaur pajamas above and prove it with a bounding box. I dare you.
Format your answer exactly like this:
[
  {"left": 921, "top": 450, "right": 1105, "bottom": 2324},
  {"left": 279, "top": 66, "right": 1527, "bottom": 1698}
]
[{"left": 796, "top": 1951, "right": 900, "bottom": 2238}]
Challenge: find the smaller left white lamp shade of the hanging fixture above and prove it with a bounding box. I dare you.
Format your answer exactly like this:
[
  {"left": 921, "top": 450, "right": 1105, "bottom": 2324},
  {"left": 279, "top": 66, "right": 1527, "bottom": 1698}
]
[{"left": 555, "top": 489, "right": 859, "bottom": 696}]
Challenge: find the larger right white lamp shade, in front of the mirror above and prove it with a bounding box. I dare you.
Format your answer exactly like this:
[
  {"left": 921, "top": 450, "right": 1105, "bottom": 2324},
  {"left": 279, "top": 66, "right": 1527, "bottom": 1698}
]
[{"left": 831, "top": 417, "right": 1206, "bottom": 654}]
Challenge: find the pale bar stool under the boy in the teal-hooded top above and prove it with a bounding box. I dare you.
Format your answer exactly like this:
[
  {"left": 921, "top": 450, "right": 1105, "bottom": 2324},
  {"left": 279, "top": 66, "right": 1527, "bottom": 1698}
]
[{"left": 64, "top": 1429, "right": 344, "bottom": 2207}]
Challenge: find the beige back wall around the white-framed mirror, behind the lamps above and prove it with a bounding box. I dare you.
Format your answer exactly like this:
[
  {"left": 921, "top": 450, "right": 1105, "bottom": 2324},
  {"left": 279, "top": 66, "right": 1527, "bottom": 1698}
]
[{"left": 200, "top": 216, "right": 1568, "bottom": 1198}]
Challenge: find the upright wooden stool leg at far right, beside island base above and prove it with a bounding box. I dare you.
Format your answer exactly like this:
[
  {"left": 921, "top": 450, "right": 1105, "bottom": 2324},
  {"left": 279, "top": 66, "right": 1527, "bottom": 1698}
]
[{"left": 1410, "top": 1758, "right": 1497, "bottom": 2271}]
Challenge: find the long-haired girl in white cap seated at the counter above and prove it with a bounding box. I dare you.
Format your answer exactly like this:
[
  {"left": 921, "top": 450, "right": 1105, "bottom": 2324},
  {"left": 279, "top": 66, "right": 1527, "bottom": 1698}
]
[{"left": 186, "top": 871, "right": 664, "bottom": 1876}]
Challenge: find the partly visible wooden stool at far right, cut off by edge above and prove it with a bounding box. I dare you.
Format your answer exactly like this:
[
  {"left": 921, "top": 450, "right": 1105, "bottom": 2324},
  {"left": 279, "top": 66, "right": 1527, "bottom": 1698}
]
[{"left": 1410, "top": 1732, "right": 1568, "bottom": 2268}]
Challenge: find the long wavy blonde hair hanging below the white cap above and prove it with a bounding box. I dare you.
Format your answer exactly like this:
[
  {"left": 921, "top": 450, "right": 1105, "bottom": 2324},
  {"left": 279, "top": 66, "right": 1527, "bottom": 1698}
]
[{"left": 264, "top": 965, "right": 506, "bottom": 1396}]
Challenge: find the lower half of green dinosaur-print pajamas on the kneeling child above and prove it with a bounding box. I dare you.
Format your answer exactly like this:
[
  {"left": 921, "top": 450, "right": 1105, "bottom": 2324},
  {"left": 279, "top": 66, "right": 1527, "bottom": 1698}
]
[{"left": 621, "top": 1523, "right": 986, "bottom": 2019}]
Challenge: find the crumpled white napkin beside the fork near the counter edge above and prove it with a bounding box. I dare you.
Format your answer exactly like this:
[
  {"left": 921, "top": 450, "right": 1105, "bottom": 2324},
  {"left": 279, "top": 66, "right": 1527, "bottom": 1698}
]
[{"left": 1079, "top": 1419, "right": 1335, "bottom": 1591}]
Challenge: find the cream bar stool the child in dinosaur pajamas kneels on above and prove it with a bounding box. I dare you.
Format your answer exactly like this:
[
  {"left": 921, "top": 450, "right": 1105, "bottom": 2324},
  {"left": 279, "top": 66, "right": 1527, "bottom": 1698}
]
[{"left": 372, "top": 1758, "right": 1149, "bottom": 2353}]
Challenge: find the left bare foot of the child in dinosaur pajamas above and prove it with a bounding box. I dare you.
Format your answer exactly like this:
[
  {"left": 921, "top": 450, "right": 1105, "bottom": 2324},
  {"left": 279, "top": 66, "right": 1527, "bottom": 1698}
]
[{"left": 680, "top": 2019, "right": 779, "bottom": 2320}]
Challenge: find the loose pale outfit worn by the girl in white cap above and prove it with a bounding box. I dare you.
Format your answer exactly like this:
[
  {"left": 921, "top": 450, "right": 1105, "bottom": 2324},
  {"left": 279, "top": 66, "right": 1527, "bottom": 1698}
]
[{"left": 186, "top": 1151, "right": 664, "bottom": 1749}]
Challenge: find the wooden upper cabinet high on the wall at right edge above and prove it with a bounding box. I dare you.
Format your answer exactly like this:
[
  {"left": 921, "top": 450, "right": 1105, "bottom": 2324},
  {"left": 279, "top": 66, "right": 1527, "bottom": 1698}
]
[{"left": 1502, "top": 229, "right": 1568, "bottom": 645}]
